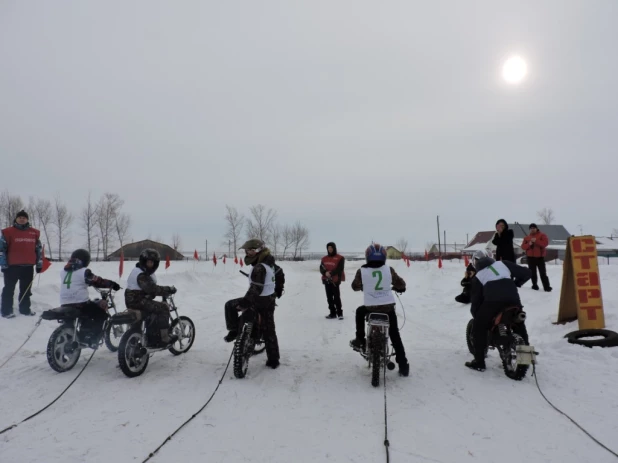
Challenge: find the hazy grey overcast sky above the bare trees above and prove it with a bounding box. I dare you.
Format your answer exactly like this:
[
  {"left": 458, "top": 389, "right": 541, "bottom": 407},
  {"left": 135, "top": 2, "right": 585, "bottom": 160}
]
[{"left": 0, "top": 0, "right": 618, "bottom": 251}]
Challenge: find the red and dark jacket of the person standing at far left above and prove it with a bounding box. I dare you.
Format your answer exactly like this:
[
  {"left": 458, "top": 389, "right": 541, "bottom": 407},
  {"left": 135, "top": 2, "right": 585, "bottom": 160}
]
[{"left": 0, "top": 222, "right": 43, "bottom": 270}]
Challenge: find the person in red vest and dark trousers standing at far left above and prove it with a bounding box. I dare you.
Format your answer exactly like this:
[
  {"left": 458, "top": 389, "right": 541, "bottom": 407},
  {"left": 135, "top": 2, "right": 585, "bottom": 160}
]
[{"left": 0, "top": 210, "right": 43, "bottom": 318}]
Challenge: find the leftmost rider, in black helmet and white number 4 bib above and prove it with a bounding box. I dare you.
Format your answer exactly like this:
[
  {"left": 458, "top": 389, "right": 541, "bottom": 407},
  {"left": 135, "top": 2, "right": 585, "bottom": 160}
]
[{"left": 60, "top": 249, "right": 120, "bottom": 347}]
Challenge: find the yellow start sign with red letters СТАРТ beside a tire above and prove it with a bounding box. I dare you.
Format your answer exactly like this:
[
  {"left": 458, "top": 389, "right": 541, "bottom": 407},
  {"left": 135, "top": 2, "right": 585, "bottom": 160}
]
[{"left": 556, "top": 236, "right": 605, "bottom": 330}]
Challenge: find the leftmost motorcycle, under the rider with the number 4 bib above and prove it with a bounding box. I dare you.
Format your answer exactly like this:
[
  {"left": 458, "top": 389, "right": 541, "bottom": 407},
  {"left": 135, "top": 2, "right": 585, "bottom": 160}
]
[{"left": 41, "top": 289, "right": 122, "bottom": 373}]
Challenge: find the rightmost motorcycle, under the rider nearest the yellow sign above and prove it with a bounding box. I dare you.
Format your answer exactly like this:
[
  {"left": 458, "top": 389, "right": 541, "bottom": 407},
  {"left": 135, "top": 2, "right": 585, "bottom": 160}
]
[{"left": 466, "top": 307, "right": 539, "bottom": 381}]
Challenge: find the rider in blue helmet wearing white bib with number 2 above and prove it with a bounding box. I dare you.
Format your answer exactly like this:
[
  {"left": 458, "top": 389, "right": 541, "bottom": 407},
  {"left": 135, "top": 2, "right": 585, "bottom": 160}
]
[{"left": 350, "top": 243, "right": 410, "bottom": 376}]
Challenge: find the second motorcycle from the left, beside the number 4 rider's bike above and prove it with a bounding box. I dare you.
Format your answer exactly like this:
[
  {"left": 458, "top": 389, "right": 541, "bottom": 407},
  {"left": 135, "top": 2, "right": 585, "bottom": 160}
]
[{"left": 110, "top": 295, "right": 195, "bottom": 378}]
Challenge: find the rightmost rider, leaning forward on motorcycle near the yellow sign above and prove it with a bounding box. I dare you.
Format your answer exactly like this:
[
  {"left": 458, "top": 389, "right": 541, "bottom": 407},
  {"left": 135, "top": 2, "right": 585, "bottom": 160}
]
[{"left": 465, "top": 251, "right": 532, "bottom": 371}]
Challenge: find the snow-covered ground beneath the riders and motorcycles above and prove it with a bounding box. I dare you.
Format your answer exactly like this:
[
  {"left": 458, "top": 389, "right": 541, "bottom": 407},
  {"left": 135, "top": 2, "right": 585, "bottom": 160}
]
[{"left": 0, "top": 262, "right": 618, "bottom": 463}]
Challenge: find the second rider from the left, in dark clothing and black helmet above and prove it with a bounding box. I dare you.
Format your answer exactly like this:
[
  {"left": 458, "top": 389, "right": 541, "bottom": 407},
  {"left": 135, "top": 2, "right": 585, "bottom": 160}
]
[{"left": 124, "top": 248, "right": 178, "bottom": 347}]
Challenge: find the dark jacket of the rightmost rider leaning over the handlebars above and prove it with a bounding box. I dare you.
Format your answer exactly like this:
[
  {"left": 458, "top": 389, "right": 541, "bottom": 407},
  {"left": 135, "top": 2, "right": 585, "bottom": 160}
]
[{"left": 470, "top": 257, "right": 532, "bottom": 317}]
